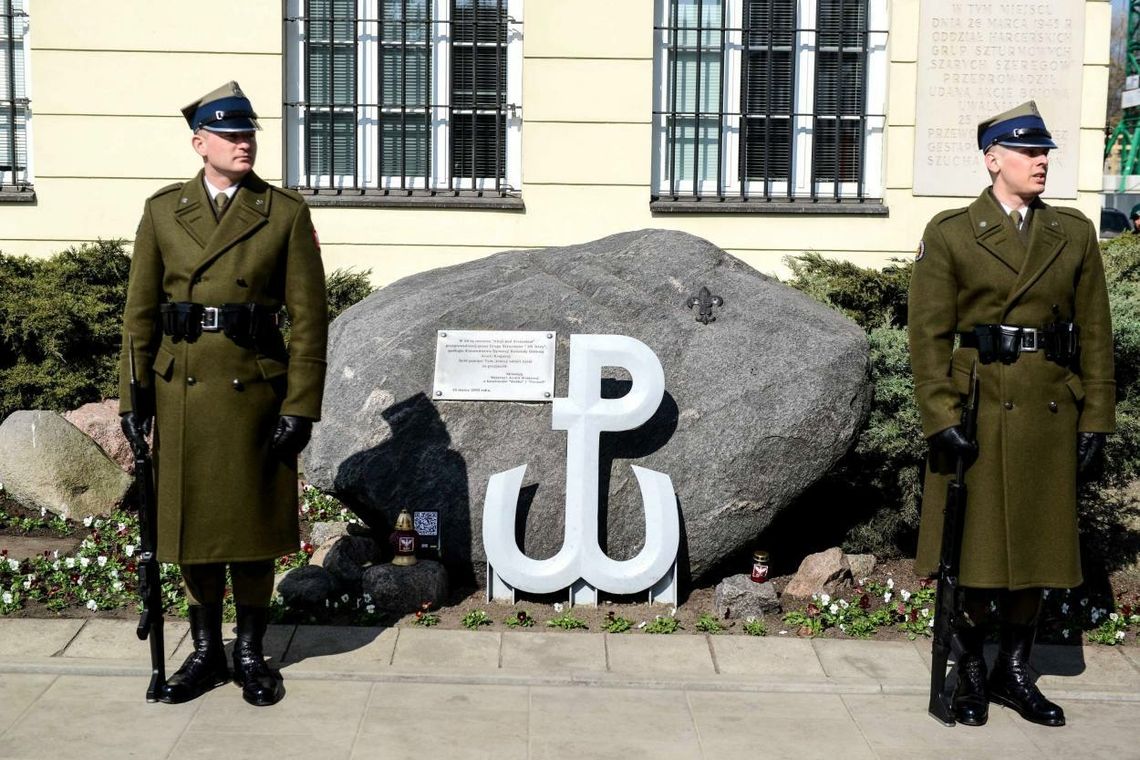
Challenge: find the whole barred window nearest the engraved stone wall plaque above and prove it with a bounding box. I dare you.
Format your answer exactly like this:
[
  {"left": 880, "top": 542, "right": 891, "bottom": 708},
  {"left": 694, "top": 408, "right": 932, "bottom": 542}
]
[{"left": 652, "top": 0, "right": 888, "bottom": 210}]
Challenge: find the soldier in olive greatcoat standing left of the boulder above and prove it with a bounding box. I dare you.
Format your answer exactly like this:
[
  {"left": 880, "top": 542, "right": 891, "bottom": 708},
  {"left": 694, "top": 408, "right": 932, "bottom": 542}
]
[{"left": 120, "top": 82, "right": 328, "bottom": 705}]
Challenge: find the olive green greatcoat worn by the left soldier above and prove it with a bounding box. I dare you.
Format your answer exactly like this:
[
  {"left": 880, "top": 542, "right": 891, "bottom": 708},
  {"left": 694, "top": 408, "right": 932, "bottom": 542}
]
[{"left": 120, "top": 172, "right": 328, "bottom": 564}]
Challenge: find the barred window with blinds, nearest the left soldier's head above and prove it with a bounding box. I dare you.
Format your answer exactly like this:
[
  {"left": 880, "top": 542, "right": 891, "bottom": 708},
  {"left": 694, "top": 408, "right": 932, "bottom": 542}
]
[{"left": 285, "top": 0, "right": 522, "bottom": 198}]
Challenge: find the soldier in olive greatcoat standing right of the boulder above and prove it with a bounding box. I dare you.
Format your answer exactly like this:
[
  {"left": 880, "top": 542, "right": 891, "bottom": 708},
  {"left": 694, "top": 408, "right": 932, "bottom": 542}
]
[{"left": 909, "top": 100, "right": 1116, "bottom": 726}]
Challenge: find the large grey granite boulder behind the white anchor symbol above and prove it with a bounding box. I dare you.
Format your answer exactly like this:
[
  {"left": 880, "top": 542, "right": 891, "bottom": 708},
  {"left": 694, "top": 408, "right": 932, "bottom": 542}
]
[{"left": 303, "top": 230, "right": 871, "bottom": 579}]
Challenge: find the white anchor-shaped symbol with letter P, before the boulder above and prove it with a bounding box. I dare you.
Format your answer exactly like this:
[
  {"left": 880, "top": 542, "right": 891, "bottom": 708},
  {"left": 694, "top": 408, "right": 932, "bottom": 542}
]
[{"left": 483, "top": 335, "right": 681, "bottom": 603}]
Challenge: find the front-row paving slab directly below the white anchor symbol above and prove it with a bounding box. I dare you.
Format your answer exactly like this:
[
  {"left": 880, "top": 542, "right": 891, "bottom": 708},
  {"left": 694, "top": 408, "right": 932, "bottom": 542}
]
[{"left": 530, "top": 686, "right": 701, "bottom": 760}]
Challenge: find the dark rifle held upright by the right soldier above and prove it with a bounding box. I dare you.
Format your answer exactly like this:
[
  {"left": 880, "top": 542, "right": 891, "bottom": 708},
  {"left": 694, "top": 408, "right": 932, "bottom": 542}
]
[{"left": 928, "top": 361, "right": 978, "bottom": 726}]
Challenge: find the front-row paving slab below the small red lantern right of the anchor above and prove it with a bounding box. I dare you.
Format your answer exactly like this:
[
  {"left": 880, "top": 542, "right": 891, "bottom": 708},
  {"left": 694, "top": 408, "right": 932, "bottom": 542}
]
[{"left": 687, "top": 690, "right": 876, "bottom": 760}]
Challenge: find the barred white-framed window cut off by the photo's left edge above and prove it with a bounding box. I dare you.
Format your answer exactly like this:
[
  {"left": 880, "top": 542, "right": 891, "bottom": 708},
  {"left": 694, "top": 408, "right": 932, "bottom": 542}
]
[{"left": 0, "top": 0, "right": 35, "bottom": 203}]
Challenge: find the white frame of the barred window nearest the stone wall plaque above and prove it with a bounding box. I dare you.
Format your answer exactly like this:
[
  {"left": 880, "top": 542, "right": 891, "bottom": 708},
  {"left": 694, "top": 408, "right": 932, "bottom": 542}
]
[{"left": 651, "top": 0, "right": 889, "bottom": 213}]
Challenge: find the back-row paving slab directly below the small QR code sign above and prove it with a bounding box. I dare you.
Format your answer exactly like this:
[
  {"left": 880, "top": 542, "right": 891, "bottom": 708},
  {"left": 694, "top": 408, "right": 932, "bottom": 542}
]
[{"left": 392, "top": 627, "right": 502, "bottom": 673}]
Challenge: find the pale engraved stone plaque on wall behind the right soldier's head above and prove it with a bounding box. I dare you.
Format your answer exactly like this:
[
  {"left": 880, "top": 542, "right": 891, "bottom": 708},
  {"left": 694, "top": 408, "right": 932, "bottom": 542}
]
[{"left": 914, "top": 0, "right": 1084, "bottom": 198}]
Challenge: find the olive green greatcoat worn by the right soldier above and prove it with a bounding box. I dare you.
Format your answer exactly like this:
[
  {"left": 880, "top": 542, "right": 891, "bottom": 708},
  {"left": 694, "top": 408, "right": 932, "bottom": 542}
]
[{"left": 909, "top": 189, "right": 1116, "bottom": 589}]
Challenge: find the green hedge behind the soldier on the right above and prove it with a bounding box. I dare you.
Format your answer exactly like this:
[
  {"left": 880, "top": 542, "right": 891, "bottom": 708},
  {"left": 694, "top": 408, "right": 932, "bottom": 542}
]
[{"left": 788, "top": 235, "right": 1140, "bottom": 571}]
